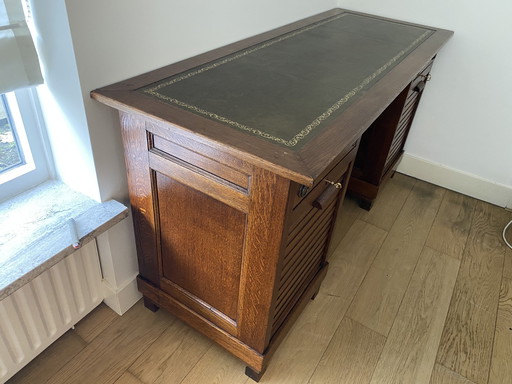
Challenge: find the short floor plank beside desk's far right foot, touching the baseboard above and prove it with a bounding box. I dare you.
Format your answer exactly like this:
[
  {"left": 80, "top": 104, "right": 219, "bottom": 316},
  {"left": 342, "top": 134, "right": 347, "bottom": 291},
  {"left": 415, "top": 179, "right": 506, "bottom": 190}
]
[{"left": 359, "top": 172, "right": 416, "bottom": 231}]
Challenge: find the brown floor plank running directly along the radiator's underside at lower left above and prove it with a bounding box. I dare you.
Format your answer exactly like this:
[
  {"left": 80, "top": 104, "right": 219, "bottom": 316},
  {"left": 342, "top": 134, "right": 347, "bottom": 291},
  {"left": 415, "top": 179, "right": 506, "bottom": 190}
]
[{"left": 7, "top": 331, "right": 86, "bottom": 384}]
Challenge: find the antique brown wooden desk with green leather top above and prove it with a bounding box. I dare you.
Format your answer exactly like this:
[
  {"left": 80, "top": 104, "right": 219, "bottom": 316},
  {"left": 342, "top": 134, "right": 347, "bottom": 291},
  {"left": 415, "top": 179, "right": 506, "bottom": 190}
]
[{"left": 92, "top": 9, "right": 452, "bottom": 380}]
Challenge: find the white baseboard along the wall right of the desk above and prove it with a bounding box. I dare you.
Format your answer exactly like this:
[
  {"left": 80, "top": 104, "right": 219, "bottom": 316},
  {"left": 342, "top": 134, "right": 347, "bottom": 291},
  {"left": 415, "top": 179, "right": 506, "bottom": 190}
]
[{"left": 397, "top": 154, "right": 512, "bottom": 209}]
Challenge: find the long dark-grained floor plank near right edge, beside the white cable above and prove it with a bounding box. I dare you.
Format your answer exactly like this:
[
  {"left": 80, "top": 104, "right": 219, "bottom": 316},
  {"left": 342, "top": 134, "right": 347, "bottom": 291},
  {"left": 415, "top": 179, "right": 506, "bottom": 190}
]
[{"left": 437, "top": 201, "right": 508, "bottom": 384}]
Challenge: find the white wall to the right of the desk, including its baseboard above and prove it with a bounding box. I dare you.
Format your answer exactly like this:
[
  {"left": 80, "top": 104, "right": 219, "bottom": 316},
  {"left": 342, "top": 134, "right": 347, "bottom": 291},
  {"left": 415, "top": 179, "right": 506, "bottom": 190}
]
[{"left": 338, "top": 0, "right": 512, "bottom": 207}]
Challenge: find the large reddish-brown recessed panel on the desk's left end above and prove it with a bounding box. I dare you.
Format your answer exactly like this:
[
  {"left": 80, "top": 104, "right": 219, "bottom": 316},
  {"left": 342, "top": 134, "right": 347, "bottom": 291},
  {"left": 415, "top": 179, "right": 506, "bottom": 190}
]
[{"left": 156, "top": 173, "right": 246, "bottom": 323}]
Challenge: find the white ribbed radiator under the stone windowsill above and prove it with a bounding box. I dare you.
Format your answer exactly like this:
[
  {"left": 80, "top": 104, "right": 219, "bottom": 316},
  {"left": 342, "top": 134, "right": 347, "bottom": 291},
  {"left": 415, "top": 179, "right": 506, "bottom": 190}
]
[{"left": 0, "top": 240, "right": 103, "bottom": 383}]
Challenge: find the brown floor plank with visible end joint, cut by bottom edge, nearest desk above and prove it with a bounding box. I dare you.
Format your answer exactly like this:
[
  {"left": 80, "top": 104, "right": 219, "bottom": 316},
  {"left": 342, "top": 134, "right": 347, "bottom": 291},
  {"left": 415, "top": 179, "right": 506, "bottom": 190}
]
[{"left": 309, "top": 317, "right": 386, "bottom": 384}]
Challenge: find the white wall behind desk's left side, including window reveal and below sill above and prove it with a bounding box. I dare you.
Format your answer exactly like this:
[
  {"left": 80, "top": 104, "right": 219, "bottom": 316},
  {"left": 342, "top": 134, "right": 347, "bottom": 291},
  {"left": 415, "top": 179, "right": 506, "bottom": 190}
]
[{"left": 33, "top": 0, "right": 336, "bottom": 313}]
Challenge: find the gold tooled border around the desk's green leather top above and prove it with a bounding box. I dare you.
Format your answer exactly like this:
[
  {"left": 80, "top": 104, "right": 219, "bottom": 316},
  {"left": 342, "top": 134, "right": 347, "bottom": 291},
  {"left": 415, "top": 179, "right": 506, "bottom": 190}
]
[{"left": 143, "top": 13, "right": 432, "bottom": 147}]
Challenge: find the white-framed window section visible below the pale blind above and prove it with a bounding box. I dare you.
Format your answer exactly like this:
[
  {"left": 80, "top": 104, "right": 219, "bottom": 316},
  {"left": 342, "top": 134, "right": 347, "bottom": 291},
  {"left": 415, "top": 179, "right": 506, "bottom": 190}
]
[{"left": 0, "top": 88, "right": 51, "bottom": 201}]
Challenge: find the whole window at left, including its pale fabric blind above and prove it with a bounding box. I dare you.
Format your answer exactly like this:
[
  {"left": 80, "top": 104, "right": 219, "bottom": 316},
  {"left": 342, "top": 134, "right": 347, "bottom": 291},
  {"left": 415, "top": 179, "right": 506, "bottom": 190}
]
[{"left": 0, "top": 0, "right": 49, "bottom": 201}]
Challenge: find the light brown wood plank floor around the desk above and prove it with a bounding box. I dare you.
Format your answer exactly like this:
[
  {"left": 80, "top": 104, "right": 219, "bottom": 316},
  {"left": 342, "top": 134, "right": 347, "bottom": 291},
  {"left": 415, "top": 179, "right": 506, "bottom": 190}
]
[{"left": 8, "top": 174, "right": 512, "bottom": 384}]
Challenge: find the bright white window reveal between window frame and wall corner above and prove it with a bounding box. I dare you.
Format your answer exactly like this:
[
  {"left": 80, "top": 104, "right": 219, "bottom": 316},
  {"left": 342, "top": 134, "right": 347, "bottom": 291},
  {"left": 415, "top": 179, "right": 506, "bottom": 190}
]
[{"left": 32, "top": 0, "right": 100, "bottom": 200}]
